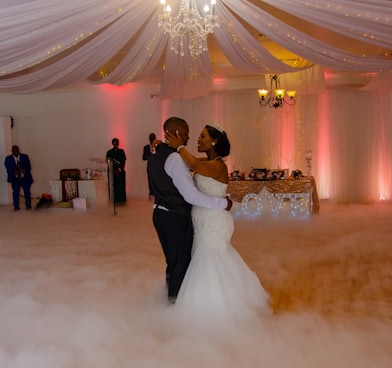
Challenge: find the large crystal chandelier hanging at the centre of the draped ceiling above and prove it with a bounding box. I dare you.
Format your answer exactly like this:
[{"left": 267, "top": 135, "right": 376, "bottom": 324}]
[{"left": 158, "top": 0, "right": 219, "bottom": 57}]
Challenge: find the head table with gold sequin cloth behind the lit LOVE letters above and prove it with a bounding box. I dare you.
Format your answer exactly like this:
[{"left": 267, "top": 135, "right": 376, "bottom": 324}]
[{"left": 227, "top": 176, "right": 320, "bottom": 214}]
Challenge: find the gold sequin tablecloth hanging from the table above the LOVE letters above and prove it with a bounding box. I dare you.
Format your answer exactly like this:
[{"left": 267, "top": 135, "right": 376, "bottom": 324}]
[{"left": 227, "top": 177, "right": 320, "bottom": 213}]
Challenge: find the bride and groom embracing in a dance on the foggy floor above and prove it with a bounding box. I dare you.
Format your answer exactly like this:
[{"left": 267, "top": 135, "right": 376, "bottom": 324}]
[{"left": 147, "top": 117, "right": 271, "bottom": 325}]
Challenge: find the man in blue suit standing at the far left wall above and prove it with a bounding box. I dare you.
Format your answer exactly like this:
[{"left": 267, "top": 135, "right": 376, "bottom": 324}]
[{"left": 4, "top": 146, "right": 33, "bottom": 211}]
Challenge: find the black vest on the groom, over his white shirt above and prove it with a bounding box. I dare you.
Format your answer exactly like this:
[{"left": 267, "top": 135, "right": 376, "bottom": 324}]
[{"left": 147, "top": 143, "right": 192, "bottom": 215}]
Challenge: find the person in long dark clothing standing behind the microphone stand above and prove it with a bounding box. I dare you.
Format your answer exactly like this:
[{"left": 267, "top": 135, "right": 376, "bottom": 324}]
[{"left": 106, "top": 138, "right": 127, "bottom": 203}]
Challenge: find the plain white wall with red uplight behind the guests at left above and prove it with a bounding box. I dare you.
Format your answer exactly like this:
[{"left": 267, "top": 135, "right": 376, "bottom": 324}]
[{"left": 0, "top": 84, "right": 162, "bottom": 198}]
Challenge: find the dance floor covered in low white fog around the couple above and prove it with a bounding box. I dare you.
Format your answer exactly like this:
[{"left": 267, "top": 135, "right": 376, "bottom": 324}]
[{"left": 0, "top": 199, "right": 392, "bottom": 368}]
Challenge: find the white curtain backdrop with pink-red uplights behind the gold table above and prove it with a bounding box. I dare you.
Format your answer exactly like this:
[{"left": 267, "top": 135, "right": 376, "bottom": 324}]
[{"left": 162, "top": 67, "right": 392, "bottom": 202}]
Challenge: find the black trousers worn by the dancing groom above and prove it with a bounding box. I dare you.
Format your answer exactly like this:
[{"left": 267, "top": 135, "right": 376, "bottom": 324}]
[{"left": 153, "top": 208, "right": 193, "bottom": 297}]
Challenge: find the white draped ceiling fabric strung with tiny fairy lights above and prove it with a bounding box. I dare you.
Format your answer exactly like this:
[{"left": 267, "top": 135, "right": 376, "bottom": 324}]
[{"left": 0, "top": 0, "right": 392, "bottom": 98}]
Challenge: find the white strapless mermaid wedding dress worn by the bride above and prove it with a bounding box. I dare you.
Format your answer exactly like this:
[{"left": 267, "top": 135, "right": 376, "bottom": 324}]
[{"left": 174, "top": 174, "right": 271, "bottom": 330}]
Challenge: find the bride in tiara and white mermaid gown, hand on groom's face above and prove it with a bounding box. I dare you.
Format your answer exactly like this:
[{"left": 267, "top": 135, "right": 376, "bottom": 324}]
[{"left": 165, "top": 124, "right": 271, "bottom": 329}]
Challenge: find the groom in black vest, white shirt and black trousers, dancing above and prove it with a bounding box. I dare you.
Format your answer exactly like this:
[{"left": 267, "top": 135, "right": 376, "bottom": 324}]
[{"left": 147, "top": 117, "right": 233, "bottom": 303}]
